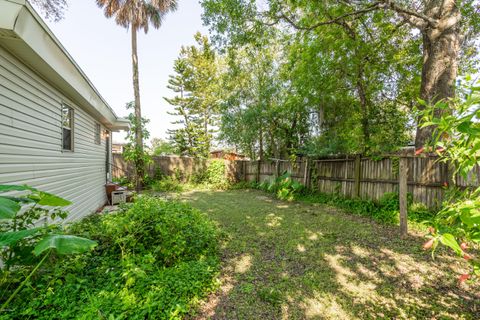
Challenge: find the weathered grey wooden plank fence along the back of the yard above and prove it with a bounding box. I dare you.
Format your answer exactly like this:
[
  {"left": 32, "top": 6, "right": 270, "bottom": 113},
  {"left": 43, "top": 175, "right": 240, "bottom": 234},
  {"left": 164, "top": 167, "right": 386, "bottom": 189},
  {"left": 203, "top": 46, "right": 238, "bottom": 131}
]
[{"left": 112, "top": 155, "right": 480, "bottom": 208}]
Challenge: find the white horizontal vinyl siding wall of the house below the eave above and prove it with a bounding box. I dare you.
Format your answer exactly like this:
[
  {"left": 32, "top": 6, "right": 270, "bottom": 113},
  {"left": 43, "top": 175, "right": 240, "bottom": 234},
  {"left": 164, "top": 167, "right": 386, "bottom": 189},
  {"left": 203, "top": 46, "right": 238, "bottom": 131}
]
[{"left": 0, "top": 47, "right": 107, "bottom": 220}]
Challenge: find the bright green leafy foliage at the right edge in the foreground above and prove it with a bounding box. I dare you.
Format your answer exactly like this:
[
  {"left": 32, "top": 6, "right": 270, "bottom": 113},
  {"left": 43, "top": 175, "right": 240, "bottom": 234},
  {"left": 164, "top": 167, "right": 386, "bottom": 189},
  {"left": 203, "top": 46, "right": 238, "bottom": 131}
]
[{"left": 422, "top": 78, "right": 480, "bottom": 281}]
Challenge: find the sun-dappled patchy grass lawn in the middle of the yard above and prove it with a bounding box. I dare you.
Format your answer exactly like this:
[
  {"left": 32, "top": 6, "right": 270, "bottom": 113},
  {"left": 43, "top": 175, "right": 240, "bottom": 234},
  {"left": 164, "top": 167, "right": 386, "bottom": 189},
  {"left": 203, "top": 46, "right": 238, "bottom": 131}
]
[{"left": 181, "top": 190, "right": 480, "bottom": 319}]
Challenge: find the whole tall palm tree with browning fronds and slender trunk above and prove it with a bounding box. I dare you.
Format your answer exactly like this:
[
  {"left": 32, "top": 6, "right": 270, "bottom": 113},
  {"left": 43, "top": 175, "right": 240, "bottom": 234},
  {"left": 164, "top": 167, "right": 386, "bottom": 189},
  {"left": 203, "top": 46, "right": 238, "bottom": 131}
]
[{"left": 96, "top": 0, "right": 178, "bottom": 191}]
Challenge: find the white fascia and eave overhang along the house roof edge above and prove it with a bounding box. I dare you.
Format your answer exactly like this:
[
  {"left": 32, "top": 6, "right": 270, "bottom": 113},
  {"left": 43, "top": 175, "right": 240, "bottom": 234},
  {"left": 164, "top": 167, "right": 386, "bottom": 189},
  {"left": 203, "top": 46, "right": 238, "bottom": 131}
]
[{"left": 0, "top": 0, "right": 128, "bottom": 130}]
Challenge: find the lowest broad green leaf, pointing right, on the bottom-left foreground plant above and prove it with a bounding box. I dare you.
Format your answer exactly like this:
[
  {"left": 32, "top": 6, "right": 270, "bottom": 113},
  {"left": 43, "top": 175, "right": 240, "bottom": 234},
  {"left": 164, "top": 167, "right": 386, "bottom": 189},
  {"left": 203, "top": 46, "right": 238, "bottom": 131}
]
[{"left": 33, "top": 234, "right": 97, "bottom": 256}]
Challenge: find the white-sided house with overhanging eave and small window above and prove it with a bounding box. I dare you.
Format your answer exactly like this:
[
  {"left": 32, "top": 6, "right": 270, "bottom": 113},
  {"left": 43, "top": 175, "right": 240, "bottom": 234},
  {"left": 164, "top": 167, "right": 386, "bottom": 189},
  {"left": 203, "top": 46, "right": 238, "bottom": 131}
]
[{"left": 0, "top": 0, "right": 129, "bottom": 219}]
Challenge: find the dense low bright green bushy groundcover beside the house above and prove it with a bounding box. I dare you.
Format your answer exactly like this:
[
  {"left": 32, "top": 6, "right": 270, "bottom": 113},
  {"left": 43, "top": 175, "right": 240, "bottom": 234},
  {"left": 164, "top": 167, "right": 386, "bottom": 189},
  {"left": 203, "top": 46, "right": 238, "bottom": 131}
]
[{"left": 0, "top": 197, "right": 219, "bottom": 319}]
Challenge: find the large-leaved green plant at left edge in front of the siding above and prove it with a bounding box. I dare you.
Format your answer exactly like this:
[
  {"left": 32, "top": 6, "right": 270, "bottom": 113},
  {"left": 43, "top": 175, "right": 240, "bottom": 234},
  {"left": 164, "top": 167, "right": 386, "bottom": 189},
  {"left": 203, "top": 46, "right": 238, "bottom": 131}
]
[{"left": 0, "top": 185, "right": 96, "bottom": 310}]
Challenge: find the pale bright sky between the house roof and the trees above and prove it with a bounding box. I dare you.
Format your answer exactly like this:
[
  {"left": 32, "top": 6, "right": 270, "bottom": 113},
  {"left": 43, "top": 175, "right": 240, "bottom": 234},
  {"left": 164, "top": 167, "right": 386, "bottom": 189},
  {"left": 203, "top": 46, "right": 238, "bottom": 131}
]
[{"left": 40, "top": 0, "right": 207, "bottom": 142}]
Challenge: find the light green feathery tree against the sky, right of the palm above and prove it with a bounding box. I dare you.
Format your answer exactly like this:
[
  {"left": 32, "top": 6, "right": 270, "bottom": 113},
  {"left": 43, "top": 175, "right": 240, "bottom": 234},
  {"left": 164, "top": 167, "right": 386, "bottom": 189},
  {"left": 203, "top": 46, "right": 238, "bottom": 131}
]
[{"left": 164, "top": 33, "right": 220, "bottom": 158}]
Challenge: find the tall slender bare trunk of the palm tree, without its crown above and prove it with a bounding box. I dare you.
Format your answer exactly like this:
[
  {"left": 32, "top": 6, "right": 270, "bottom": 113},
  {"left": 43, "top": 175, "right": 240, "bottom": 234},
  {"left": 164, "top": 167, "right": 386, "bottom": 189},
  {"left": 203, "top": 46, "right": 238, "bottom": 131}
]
[{"left": 132, "top": 26, "right": 145, "bottom": 192}]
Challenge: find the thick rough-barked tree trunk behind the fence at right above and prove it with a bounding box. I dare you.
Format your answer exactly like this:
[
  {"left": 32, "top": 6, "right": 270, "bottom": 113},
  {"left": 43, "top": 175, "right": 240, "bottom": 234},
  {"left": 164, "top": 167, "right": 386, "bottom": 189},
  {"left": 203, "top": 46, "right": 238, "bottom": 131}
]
[{"left": 415, "top": 0, "right": 461, "bottom": 148}]
